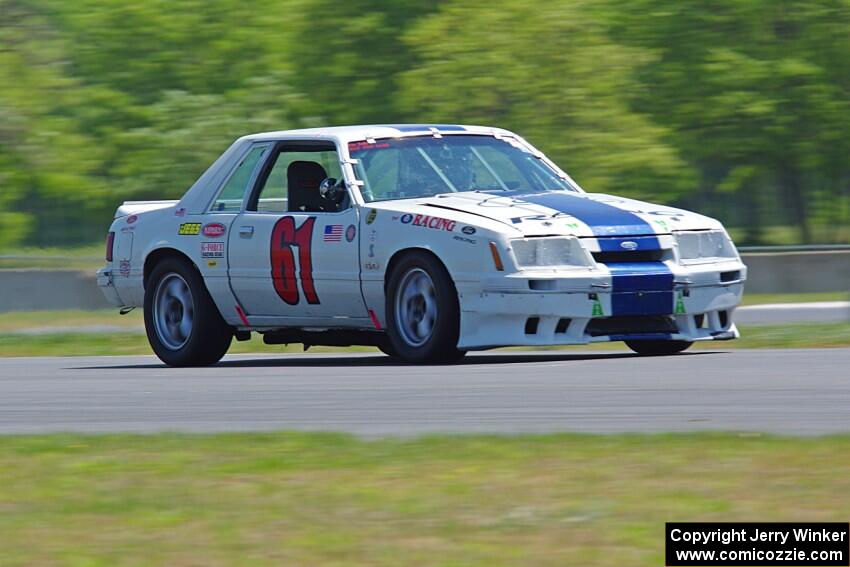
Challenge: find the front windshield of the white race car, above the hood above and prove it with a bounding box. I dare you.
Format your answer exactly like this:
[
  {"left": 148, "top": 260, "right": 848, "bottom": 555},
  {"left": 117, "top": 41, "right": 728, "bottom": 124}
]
[{"left": 348, "top": 135, "right": 576, "bottom": 202}]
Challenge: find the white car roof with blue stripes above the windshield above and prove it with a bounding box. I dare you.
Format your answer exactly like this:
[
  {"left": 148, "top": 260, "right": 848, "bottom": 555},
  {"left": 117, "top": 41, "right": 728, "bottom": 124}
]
[{"left": 240, "top": 124, "right": 512, "bottom": 143}]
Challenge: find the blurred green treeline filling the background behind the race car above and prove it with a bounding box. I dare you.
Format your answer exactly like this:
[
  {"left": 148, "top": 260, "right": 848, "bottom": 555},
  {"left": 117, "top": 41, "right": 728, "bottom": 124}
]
[{"left": 0, "top": 0, "right": 850, "bottom": 250}]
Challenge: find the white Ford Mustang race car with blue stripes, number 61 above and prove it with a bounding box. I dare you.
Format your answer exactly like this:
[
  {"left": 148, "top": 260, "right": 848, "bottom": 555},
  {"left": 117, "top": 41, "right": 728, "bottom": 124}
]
[{"left": 98, "top": 125, "right": 746, "bottom": 366}]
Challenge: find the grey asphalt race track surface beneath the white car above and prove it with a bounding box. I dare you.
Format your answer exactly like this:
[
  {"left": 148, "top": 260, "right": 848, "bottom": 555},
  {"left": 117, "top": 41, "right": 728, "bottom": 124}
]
[{"left": 0, "top": 349, "right": 850, "bottom": 436}]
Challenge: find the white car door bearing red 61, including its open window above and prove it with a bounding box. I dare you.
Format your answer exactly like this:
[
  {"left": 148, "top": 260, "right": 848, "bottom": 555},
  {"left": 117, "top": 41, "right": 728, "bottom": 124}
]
[{"left": 228, "top": 140, "right": 368, "bottom": 326}]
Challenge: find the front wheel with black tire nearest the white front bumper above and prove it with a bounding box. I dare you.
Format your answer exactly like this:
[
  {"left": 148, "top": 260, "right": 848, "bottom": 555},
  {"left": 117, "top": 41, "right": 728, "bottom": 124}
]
[{"left": 382, "top": 252, "right": 466, "bottom": 364}]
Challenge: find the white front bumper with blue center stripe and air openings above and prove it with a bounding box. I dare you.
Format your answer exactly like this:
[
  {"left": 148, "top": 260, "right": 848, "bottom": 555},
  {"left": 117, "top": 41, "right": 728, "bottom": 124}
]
[{"left": 458, "top": 261, "right": 746, "bottom": 350}]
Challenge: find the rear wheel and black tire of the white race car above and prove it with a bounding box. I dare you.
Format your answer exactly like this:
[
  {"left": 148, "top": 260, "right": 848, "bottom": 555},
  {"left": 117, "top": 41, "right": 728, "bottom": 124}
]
[{"left": 145, "top": 258, "right": 233, "bottom": 366}]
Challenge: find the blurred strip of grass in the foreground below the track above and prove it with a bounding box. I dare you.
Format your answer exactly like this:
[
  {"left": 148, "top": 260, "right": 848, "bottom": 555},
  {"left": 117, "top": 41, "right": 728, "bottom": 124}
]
[{"left": 0, "top": 433, "right": 850, "bottom": 567}]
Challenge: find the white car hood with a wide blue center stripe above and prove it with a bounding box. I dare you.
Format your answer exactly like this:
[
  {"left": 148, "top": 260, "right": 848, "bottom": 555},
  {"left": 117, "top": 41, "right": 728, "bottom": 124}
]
[{"left": 384, "top": 191, "right": 722, "bottom": 237}]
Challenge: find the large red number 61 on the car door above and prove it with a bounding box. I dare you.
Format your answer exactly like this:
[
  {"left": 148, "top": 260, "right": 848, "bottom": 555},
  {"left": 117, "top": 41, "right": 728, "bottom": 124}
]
[{"left": 271, "top": 217, "right": 320, "bottom": 305}]
